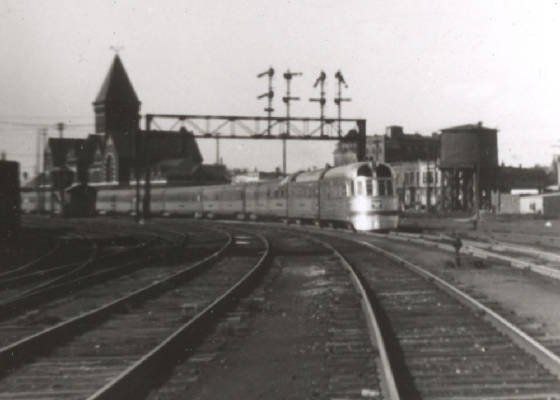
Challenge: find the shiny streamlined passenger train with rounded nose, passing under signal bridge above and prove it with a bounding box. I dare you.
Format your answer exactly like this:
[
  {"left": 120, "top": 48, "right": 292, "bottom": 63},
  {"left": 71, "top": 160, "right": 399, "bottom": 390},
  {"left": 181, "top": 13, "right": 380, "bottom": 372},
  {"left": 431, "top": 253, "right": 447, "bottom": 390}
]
[{"left": 23, "top": 162, "right": 399, "bottom": 230}]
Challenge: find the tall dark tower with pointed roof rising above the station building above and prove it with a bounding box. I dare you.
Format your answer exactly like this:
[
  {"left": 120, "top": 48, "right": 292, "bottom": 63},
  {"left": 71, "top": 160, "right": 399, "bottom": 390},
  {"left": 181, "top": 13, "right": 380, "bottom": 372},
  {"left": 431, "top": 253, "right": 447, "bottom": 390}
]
[{"left": 93, "top": 54, "right": 140, "bottom": 136}]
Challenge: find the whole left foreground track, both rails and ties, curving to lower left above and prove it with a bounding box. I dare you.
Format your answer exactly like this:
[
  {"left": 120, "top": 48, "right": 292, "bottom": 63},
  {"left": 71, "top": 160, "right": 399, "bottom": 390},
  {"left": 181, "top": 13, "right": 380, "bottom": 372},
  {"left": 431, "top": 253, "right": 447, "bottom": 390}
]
[{"left": 0, "top": 228, "right": 268, "bottom": 399}]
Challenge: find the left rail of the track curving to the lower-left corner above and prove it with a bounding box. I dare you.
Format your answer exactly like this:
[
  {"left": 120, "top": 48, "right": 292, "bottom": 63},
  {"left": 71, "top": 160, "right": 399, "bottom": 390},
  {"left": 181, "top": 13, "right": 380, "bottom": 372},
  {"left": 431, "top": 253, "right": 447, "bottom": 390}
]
[{"left": 0, "top": 230, "right": 233, "bottom": 375}]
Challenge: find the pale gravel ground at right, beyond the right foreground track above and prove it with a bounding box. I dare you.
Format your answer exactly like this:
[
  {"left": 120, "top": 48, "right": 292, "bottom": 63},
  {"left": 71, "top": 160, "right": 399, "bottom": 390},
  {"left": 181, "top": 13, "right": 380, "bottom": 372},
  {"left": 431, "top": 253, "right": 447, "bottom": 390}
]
[{"left": 402, "top": 214, "right": 560, "bottom": 336}]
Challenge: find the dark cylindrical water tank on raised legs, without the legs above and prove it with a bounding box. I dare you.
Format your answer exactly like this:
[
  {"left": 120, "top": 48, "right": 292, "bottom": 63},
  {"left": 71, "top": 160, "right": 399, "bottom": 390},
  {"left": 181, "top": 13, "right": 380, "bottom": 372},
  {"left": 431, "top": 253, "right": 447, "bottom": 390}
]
[{"left": 440, "top": 123, "right": 498, "bottom": 168}]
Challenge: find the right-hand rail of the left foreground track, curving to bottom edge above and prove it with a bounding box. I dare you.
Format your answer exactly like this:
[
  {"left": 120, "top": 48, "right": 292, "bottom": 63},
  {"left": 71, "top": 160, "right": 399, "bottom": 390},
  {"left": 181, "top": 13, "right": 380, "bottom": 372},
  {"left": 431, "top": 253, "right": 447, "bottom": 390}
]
[{"left": 87, "top": 234, "right": 270, "bottom": 400}]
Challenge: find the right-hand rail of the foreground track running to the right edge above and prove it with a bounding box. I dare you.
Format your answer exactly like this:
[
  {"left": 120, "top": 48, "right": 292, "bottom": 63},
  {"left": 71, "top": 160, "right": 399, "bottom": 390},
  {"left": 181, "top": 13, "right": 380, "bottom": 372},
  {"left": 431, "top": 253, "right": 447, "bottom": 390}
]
[{"left": 360, "top": 239, "right": 560, "bottom": 378}]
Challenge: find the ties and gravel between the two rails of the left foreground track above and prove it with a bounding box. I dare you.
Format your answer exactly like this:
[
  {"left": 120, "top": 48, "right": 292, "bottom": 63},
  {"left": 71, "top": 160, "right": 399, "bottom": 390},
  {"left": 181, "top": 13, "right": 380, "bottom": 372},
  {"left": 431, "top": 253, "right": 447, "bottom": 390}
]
[{"left": 0, "top": 231, "right": 262, "bottom": 399}]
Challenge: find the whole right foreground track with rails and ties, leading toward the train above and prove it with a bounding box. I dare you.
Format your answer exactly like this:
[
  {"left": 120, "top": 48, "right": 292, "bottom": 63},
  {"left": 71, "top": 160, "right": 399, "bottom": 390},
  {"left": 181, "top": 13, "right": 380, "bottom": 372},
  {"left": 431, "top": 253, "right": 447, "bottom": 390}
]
[{"left": 209, "top": 223, "right": 560, "bottom": 400}]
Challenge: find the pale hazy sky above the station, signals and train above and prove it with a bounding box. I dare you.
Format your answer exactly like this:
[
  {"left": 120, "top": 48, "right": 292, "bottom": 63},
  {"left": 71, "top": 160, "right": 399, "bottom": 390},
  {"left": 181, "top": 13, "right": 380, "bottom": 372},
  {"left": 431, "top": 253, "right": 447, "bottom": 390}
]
[{"left": 0, "top": 0, "right": 560, "bottom": 178}]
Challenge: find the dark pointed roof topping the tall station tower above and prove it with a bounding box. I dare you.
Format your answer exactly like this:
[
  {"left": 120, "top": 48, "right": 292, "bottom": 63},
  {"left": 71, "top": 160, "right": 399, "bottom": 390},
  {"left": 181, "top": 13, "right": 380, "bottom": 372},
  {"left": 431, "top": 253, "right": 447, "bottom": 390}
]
[{"left": 94, "top": 54, "right": 140, "bottom": 104}]
